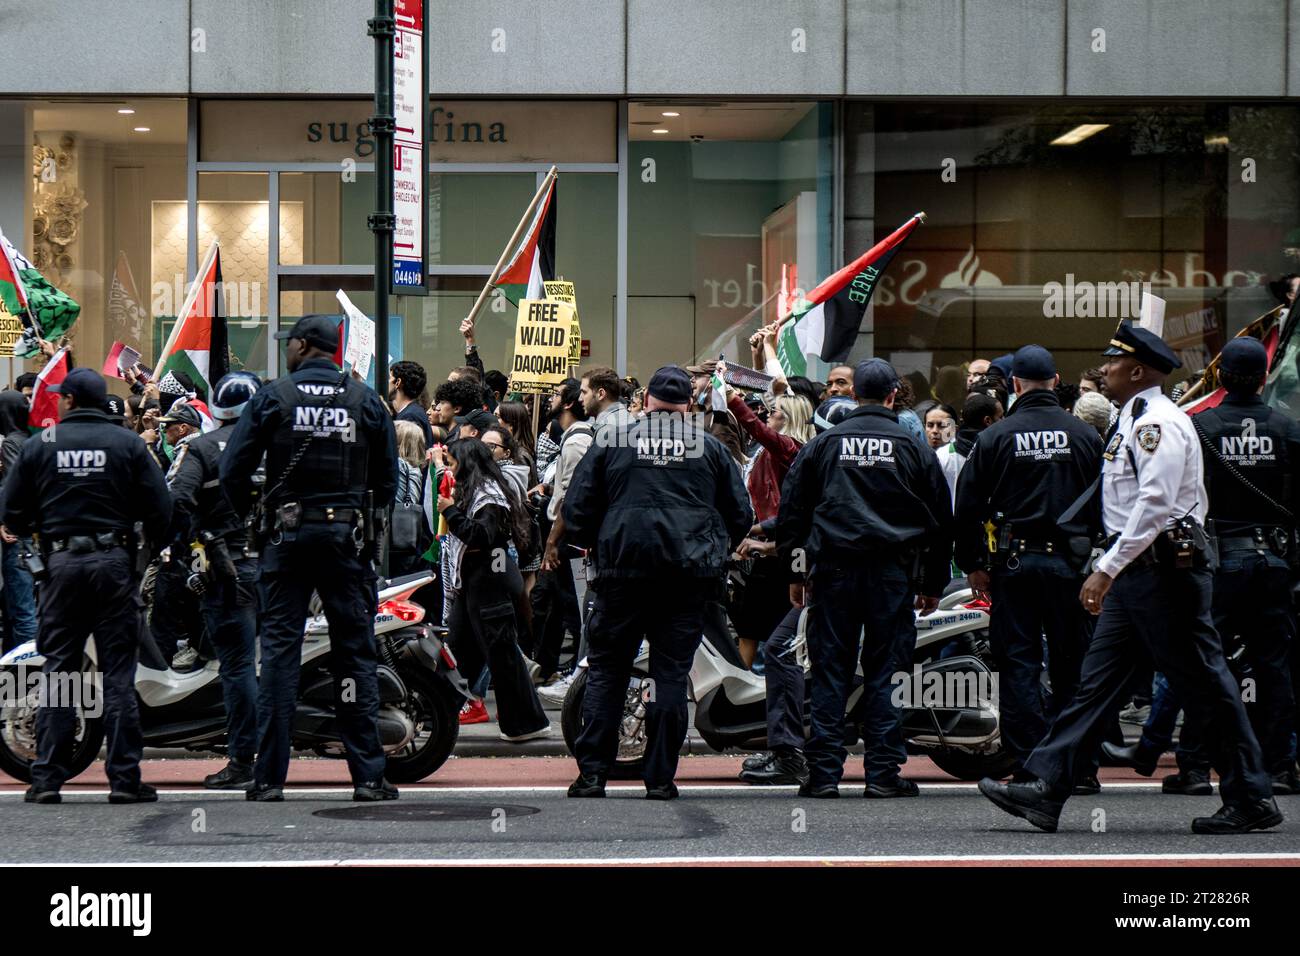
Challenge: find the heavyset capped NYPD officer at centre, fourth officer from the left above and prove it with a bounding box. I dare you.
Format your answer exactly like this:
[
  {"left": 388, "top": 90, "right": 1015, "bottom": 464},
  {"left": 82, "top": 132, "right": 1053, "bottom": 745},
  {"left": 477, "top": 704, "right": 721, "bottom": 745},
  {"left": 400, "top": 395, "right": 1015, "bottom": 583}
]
[{"left": 563, "top": 365, "right": 754, "bottom": 800}]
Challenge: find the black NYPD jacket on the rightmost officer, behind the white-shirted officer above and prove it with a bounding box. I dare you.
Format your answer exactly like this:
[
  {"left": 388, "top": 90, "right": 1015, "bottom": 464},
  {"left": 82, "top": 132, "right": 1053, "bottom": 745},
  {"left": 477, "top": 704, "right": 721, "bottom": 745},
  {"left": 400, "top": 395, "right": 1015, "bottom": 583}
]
[{"left": 1195, "top": 395, "right": 1300, "bottom": 536}]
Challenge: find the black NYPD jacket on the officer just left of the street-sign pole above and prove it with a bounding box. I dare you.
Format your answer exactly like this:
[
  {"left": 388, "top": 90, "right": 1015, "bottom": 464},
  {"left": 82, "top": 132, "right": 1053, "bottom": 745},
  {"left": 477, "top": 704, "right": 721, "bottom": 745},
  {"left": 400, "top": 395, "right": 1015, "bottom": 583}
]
[{"left": 221, "top": 359, "right": 398, "bottom": 514}]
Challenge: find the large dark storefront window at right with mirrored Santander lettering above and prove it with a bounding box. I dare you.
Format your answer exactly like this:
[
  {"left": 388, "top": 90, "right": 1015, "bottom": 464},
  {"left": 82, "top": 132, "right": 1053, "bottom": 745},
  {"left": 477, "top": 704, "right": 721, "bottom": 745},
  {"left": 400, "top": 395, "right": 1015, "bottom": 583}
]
[{"left": 845, "top": 101, "right": 1300, "bottom": 403}]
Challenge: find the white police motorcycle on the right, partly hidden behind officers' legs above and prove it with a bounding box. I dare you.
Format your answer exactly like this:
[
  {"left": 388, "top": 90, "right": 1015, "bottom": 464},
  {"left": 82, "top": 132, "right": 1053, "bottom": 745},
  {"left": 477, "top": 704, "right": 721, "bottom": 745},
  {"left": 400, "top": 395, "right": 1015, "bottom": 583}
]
[{"left": 560, "top": 588, "right": 1013, "bottom": 780}]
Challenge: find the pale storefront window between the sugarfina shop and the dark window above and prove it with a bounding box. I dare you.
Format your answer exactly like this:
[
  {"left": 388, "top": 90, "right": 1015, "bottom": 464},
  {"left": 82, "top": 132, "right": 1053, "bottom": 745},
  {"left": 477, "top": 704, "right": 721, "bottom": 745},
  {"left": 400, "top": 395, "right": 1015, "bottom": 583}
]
[{"left": 628, "top": 103, "right": 837, "bottom": 380}]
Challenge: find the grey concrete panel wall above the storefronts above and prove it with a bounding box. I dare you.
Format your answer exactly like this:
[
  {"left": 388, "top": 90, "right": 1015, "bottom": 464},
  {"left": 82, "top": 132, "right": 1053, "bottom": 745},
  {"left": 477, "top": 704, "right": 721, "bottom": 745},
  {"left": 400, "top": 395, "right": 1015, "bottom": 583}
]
[{"left": 0, "top": 0, "right": 1300, "bottom": 98}]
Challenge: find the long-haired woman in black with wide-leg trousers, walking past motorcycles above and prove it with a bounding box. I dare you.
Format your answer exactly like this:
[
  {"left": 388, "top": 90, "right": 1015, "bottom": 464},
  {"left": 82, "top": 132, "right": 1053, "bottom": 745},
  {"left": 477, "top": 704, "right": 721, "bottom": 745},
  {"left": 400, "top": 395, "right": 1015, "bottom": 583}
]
[{"left": 438, "top": 440, "right": 551, "bottom": 743}]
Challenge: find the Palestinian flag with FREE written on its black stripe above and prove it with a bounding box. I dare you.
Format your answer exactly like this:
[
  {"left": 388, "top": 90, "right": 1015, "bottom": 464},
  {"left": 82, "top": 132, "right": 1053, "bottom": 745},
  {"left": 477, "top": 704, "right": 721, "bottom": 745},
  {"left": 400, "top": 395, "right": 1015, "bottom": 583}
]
[{"left": 776, "top": 212, "right": 926, "bottom": 377}]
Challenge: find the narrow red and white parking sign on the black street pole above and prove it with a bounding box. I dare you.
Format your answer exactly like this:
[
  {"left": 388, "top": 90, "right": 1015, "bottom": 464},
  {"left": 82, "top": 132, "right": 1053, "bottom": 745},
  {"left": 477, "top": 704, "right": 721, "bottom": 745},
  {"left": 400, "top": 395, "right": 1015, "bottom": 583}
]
[{"left": 391, "top": 0, "right": 425, "bottom": 294}]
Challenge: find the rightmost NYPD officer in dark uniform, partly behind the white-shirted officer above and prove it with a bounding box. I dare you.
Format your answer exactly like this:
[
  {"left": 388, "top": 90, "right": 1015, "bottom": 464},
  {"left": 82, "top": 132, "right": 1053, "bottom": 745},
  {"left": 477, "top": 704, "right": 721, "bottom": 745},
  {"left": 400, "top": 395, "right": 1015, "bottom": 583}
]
[{"left": 1102, "top": 337, "right": 1300, "bottom": 793}]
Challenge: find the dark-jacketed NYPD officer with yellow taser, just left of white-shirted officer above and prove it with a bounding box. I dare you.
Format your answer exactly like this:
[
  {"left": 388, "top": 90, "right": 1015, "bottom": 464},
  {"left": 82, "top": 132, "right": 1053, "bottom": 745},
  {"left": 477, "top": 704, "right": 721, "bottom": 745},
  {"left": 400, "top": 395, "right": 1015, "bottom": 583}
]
[{"left": 954, "top": 345, "right": 1101, "bottom": 792}]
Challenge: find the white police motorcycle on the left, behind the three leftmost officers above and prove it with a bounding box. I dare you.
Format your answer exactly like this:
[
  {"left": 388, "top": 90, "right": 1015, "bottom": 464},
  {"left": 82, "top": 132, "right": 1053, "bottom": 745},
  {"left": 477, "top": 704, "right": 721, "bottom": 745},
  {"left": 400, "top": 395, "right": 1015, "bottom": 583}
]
[{"left": 0, "top": 574, "right": 471, "bottom": 783}]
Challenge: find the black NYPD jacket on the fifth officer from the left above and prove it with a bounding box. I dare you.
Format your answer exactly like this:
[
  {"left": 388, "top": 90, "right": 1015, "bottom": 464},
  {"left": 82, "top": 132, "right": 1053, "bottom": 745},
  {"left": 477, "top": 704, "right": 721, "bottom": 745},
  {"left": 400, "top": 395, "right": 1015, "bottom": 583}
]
[{"left": 776, "top": 405, "right": 953, "bottom": 596}]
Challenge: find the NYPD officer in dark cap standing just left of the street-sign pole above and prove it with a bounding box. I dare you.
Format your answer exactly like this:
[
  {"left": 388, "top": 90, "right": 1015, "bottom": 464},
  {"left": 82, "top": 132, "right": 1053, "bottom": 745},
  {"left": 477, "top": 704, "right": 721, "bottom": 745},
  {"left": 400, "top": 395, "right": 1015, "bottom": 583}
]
[{"left": 221, "top": 315, "right": 398, "bottom": 800}]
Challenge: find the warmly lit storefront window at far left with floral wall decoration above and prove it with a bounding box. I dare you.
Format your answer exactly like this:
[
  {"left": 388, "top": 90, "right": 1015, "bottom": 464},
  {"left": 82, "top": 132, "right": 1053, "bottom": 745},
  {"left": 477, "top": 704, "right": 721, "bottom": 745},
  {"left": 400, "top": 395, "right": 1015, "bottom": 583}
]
[{"left": 0, "top": 99, "right": 187, "bottom": 393}]
